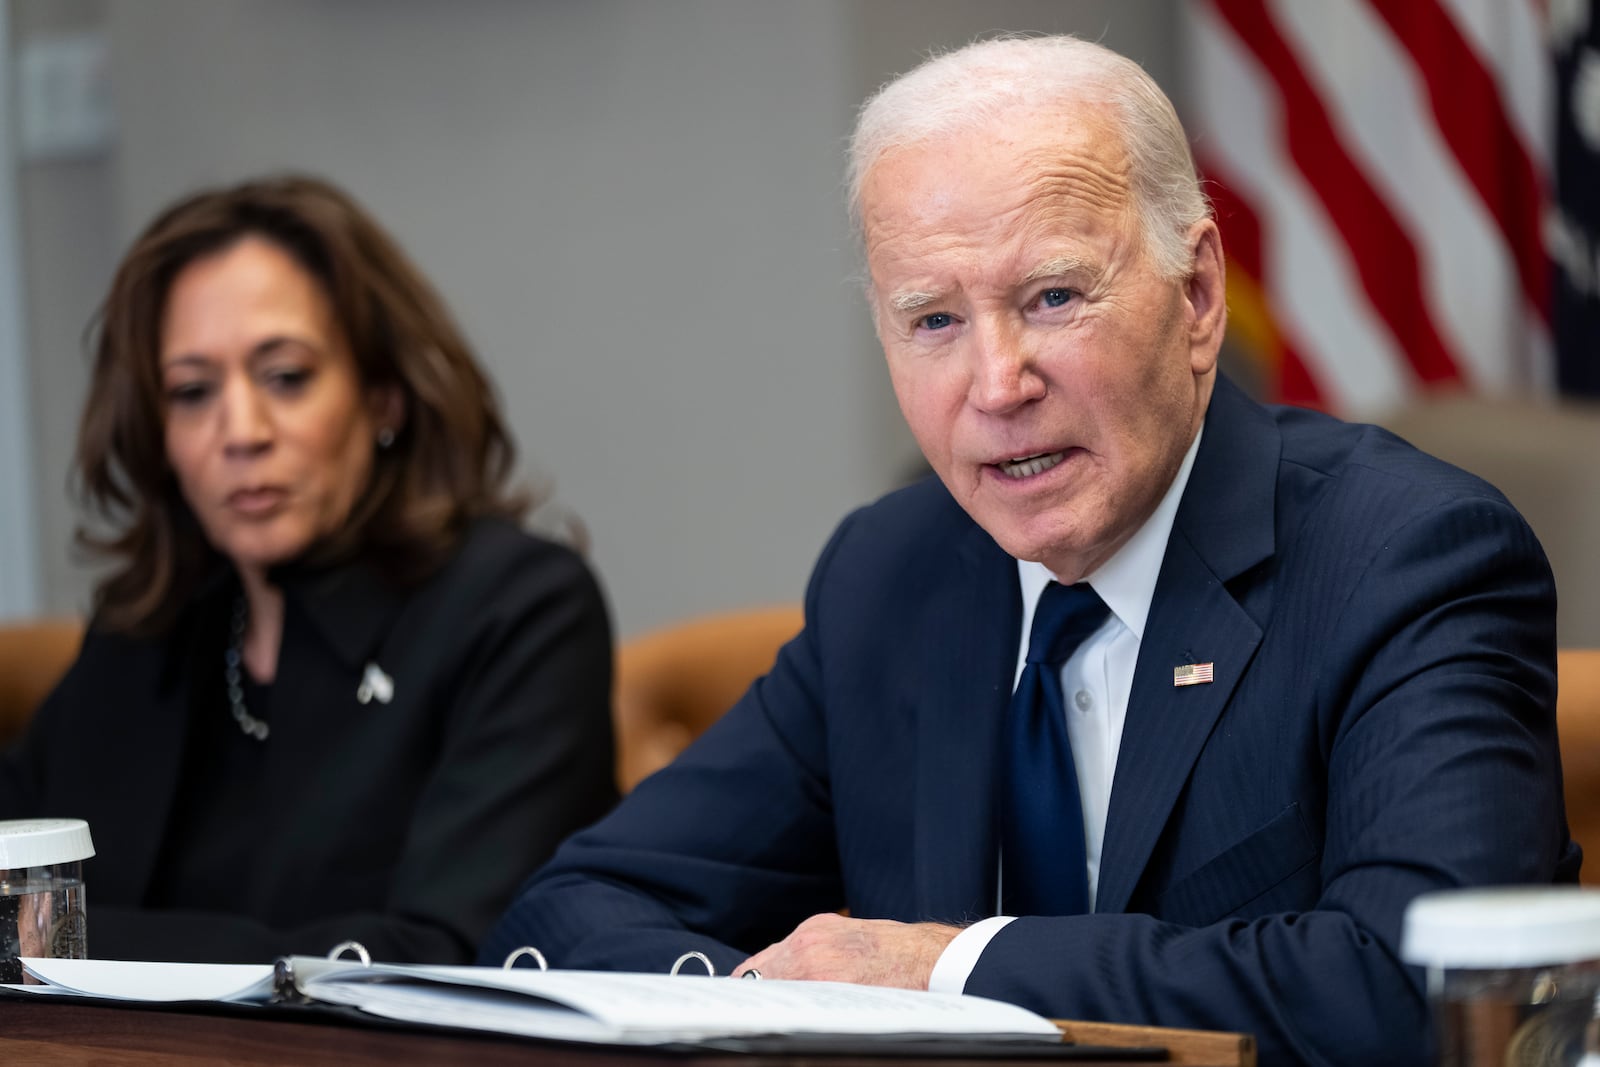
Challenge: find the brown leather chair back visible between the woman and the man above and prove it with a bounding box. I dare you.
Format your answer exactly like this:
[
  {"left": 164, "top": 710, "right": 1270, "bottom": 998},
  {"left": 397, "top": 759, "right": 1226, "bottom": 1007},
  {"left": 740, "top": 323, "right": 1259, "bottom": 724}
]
[{"left": 614, "top": 605, "right": 805, "bottom": 792}]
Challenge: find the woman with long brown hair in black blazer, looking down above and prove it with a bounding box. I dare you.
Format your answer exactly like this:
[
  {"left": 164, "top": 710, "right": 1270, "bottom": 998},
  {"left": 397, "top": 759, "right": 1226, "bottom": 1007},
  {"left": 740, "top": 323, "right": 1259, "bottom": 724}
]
[{"left": 0, "top": 178, "right": 614, "bottom": 961}]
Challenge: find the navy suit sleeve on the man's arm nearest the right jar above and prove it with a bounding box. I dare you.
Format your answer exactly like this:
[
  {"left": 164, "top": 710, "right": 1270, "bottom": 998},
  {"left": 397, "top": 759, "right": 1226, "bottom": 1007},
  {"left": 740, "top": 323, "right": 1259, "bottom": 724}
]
[{"left": 966, "top": 489, "right": 1576, "bottom": 1064}]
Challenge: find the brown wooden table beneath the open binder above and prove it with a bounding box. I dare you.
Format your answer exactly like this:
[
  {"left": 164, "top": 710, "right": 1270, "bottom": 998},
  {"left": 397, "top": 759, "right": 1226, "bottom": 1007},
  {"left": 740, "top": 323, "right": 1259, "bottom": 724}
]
[{"left": 0, "top": 995, "right": 1254, "bottom": 1067}]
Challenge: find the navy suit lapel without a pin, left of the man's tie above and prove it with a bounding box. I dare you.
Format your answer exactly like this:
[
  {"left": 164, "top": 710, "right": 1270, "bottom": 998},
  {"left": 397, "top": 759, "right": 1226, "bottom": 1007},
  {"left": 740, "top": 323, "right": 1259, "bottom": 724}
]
[{"left": 910, "top": 517, "right": 1022, "bottom": 921}]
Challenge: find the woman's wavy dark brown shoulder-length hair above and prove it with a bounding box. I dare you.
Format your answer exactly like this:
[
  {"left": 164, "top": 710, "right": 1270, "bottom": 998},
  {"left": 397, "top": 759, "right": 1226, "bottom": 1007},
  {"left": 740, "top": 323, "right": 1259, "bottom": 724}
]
[{"left": 75, "top": 176, "right": 528, "bottom": 633}]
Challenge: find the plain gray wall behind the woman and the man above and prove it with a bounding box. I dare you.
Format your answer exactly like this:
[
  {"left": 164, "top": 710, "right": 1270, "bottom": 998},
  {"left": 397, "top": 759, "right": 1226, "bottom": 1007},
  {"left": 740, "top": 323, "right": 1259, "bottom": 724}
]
[{"left": 14, "top": 0, "right": 1176, "bottom": 633}]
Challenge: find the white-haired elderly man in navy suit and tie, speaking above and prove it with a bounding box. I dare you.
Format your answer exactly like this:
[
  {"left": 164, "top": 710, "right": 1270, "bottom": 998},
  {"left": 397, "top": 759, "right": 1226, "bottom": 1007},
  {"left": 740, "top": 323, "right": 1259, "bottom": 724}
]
[{"left": 485, "top": 38, "right": 1578, "bottom": 1064}]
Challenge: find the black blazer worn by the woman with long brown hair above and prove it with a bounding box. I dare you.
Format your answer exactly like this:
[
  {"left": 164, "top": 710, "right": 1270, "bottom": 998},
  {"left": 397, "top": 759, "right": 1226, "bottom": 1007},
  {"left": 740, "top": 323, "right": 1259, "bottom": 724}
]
[{"left": 0, "top": 520, "right": 614, "bottom": 961}]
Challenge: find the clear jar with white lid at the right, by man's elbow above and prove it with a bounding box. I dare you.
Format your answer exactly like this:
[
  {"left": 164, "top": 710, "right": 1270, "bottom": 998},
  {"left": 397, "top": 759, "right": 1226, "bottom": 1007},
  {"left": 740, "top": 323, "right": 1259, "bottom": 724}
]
[{"left": 1400, "top": 886, "right": 1600, "bottom": 1067}]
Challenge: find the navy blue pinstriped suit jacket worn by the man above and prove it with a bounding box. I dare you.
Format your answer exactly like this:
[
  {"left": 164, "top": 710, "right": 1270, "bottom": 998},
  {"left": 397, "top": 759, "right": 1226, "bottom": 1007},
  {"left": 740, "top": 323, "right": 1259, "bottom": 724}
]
[{"left": 483, "top": 381, "right": 1578, "bottom": 1064}]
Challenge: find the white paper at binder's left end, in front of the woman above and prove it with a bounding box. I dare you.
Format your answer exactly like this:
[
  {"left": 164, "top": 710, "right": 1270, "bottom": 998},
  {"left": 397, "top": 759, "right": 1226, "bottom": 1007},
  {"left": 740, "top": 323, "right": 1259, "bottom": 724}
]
[{"left": 22, "top": 957, "right": 272, "bottom": 1001}]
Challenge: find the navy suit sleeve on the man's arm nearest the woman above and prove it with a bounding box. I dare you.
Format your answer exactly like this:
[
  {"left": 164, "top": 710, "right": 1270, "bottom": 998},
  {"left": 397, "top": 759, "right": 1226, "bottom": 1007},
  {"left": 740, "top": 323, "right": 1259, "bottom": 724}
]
[{"left": 478, "top": 520, "right": 850, "bottom": 974}]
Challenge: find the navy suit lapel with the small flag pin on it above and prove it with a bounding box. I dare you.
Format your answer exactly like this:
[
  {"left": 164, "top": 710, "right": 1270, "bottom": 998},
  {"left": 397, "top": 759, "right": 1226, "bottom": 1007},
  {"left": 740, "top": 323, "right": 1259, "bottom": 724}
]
[{"left": 1094, "top": 378, "right": 1280, "bottom": 912}]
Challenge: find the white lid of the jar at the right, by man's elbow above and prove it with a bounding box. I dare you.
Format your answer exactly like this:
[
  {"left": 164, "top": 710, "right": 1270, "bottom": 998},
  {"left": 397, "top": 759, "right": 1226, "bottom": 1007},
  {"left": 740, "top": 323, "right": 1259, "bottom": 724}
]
[{"left": 1400, "top": 886, "right": 1600, "bottom": 968}]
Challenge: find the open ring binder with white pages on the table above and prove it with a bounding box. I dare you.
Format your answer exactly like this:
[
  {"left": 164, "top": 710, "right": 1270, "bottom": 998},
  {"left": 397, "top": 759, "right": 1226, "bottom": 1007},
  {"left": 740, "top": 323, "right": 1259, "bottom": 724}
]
[{"left": 13, "top": 957, "right": 1165, "bottom": 1059}]
